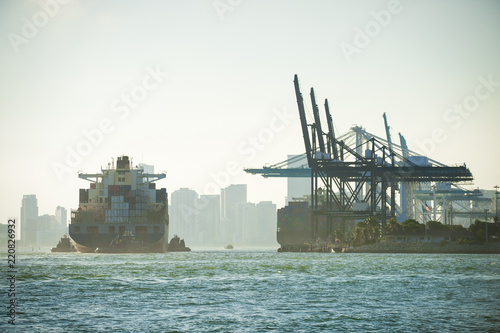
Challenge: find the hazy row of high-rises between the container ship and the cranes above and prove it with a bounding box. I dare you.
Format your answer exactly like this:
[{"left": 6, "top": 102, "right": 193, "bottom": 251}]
[{"left": 169, "top": 184, "right": 277, "bottom": 247}]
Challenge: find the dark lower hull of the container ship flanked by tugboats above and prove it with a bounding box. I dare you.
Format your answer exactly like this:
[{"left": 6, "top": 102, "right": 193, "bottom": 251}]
[{"left": 69, "top": 223, "right": 168, "bottom": 253}]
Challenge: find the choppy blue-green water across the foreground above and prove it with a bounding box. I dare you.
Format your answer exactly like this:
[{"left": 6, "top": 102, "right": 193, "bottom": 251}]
[{"left": 5, "top": 250, "right": 500, "bottom": 332}]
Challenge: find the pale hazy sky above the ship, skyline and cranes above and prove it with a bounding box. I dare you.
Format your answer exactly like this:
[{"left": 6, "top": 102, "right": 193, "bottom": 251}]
[{"left": 0, "top": 0, "right": 500, "bottom": 223}]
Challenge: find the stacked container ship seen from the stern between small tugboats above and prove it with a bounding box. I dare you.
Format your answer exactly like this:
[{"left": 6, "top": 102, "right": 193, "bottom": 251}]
[{"left": 69, "top": 156, "right": 168, "bottom": 253}]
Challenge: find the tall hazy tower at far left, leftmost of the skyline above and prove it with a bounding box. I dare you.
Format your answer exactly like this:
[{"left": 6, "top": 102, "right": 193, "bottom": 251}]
[{"left": 21, "top": 194, "right": 38, "bottom": 246}]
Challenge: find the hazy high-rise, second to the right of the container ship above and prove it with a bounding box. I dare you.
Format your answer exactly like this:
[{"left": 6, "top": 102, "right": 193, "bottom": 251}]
[{"left": 197, "top": 194, "right": 221, "bottom": 246}]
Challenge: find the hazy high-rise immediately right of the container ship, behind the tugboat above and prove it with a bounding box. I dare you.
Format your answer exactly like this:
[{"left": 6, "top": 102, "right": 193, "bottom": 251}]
[{"left": 169, "top": 188, "right": 198, "bottom": 240}]
